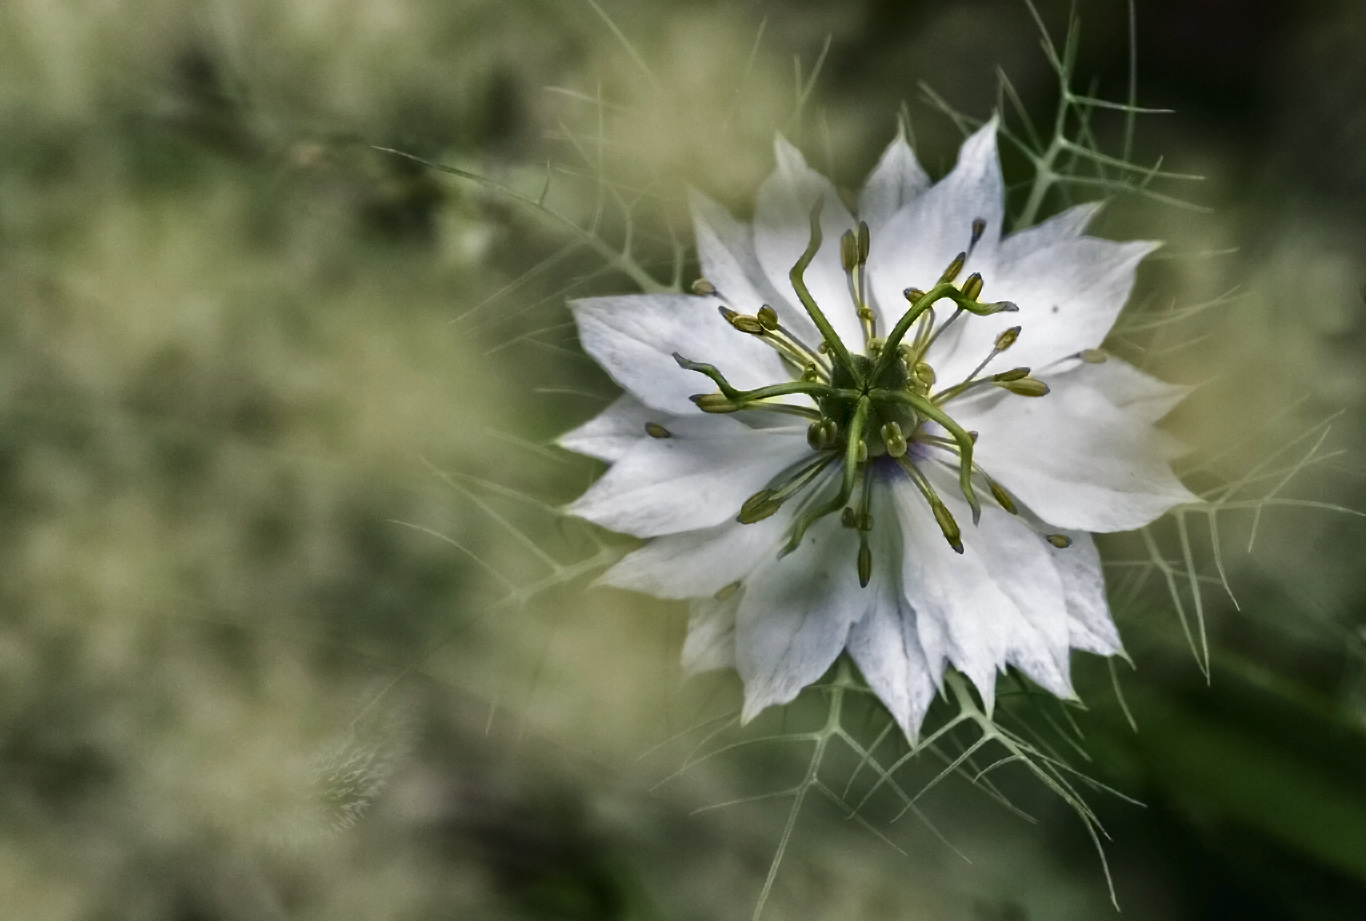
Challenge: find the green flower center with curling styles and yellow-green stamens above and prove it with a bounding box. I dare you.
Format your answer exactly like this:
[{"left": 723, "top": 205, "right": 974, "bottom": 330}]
[{"left": 673, "top": 202, "right": 1065, "bottom": 585}]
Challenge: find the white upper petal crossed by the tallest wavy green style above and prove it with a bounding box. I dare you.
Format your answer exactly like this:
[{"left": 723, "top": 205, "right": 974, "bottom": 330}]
[{"left": 754, "top": 137, "right": 863, "bottom": 347}]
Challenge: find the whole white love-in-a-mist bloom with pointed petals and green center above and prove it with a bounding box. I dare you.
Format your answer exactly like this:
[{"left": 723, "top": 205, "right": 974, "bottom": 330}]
[{"left": 561, "top": 122, "right": 1193, "bottom": 737}]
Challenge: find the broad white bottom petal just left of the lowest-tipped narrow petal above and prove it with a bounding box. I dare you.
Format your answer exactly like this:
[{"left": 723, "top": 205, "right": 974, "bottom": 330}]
[{"left": 735, "top": 515, "right": 872, "bottom": 720}]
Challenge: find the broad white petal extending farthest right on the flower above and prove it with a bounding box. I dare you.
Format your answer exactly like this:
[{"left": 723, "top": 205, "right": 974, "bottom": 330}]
[{"left": 951, "top": 374, "right": 1195, "bottom": 532}]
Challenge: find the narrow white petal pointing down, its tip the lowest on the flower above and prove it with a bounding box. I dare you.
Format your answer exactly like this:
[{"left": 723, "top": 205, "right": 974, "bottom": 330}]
[{"left": 848, "top": 505, "right": 944, "bottom": 739}]
